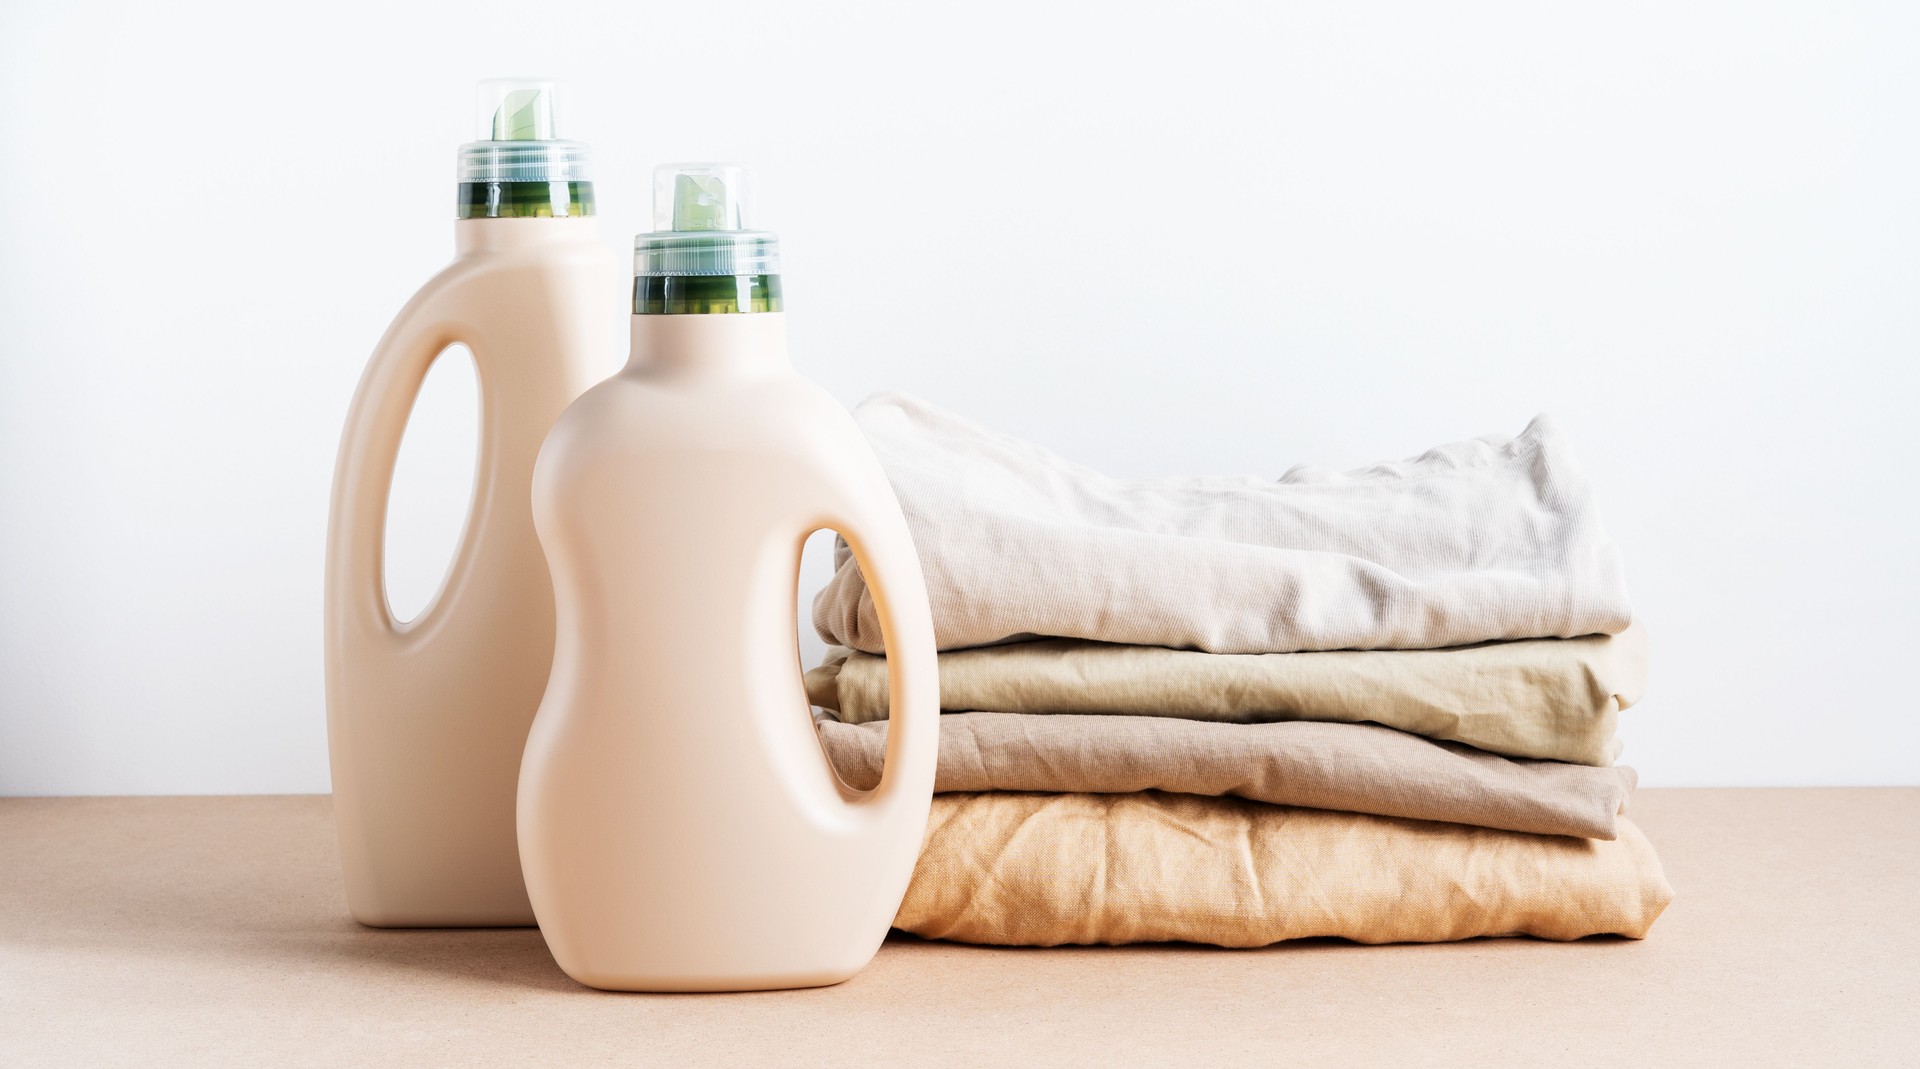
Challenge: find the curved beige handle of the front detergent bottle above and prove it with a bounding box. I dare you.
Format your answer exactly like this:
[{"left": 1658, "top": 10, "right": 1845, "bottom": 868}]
[{"left": 837, "top": 506, "right": 941, "bottom": 820}]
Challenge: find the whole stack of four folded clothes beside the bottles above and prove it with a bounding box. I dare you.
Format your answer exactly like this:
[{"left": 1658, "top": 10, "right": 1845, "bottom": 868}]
[{"left": 806, "top": 395, "right": 1672, "bottom": 946}]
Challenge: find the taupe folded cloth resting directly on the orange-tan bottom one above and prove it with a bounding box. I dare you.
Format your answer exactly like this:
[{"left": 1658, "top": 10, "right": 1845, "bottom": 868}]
[{"left": 820, "top": 712, "right": 1634, "bottom": 839}]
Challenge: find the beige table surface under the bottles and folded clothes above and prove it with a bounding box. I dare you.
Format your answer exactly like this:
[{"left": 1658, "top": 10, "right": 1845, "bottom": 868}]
[{"left": 0, "top": 789, "right": 1920, "bottom": 1069}]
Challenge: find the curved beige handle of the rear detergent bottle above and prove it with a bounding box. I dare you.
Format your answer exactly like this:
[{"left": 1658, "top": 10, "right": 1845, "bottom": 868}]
[{"left": 326, "top": 286, "right": 490, "bottom": 637}]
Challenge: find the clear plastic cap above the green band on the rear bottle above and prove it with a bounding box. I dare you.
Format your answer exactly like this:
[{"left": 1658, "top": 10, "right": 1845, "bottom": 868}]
[{"left": 459, "top": 79, "right": 588, "bottom": 182}]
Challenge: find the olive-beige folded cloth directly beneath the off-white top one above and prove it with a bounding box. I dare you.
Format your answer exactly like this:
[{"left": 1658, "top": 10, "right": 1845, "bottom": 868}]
[{"left": 806, "top": 622, "right": 1647, "bottom": 764}]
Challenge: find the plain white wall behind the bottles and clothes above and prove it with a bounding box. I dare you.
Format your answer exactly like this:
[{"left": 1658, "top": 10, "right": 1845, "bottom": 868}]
[{"left": 0, "top": 0, "right": 1920, "bottom": 793}]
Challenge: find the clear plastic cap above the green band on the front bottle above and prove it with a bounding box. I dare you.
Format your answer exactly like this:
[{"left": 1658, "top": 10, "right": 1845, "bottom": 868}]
[{"left": 634, "top": 163, "right": 780, "bottom": 276}]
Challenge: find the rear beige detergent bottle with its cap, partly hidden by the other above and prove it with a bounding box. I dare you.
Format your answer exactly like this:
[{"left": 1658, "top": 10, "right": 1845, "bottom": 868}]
[{"left": 326, "top": 81, "right": 626, "bottom": 927}]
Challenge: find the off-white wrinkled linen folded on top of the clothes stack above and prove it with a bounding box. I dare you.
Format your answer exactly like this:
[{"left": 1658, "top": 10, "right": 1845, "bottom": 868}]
[{"left": 814, "top": 393, "right": 1632, "bottom": 653}]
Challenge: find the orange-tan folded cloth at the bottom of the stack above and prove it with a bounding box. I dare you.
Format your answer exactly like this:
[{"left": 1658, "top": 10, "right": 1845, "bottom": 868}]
[{"left": 895, "top": 793, "right": 1672, "bottom": 946}]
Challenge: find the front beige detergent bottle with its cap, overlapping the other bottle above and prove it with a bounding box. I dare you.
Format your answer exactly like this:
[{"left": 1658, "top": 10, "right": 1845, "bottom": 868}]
[{"left": 520, "top": 165, "right": 939, "bottom": 990}]
